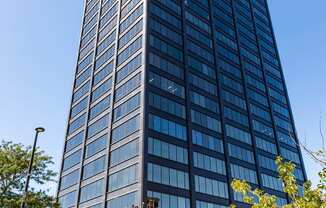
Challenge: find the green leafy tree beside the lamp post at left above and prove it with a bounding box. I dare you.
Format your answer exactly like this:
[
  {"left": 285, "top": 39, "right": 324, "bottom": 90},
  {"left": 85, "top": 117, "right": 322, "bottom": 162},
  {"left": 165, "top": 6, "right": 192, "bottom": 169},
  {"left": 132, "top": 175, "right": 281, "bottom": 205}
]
[{"left": 0, "top": 141, "right": 58, "bottom": 208}]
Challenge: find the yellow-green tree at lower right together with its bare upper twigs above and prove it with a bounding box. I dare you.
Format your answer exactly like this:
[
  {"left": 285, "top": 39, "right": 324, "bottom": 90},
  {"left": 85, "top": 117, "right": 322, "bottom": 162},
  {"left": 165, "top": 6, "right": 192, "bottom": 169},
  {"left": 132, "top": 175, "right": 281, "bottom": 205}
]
[{"left": 230, "top": 118, "right": 326, "bottom": 208}]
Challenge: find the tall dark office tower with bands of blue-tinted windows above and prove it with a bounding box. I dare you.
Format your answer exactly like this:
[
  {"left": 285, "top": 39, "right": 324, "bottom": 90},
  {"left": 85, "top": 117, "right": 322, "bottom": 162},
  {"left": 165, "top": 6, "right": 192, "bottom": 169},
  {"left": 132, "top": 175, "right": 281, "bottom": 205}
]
[{"left": 58, "top": 0, "right": 306, "bottom": 208}]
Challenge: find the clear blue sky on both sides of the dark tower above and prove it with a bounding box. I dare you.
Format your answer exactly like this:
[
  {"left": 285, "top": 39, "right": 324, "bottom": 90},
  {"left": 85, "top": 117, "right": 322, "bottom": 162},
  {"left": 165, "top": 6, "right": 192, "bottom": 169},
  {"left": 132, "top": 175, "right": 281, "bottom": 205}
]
[{"left": 0, "top": 0, "right": 326, "bottom": 195}]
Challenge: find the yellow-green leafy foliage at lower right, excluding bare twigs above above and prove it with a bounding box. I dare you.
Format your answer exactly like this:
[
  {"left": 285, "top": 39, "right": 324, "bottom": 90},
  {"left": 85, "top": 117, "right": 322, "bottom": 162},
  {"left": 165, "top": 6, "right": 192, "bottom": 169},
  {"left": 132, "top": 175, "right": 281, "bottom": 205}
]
[{"left": 230, "top": 157, "right": 326, "bottom": 208}]
